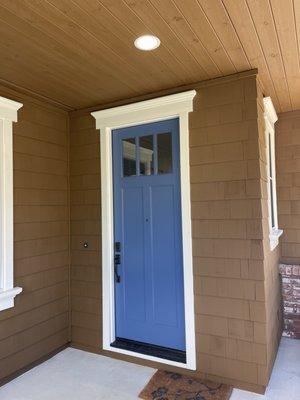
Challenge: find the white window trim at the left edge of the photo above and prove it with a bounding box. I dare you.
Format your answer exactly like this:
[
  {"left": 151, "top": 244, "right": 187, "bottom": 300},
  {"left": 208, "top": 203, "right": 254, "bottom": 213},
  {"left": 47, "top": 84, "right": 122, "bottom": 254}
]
[{"left": 0, "top": 97, "right": 23, "bottom": 311}]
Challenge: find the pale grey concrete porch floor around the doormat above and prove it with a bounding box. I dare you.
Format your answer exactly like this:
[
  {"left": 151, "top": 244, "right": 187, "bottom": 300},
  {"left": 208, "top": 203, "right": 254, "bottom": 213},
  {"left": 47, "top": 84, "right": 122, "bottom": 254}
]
[{"left": 0, "top": 338, "right": 300, "bottom": 400}]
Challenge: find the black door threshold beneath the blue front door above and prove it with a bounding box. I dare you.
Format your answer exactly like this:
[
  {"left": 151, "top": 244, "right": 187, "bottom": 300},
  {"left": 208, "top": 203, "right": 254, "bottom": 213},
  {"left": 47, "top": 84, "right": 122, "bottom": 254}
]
[{"left": 111, "top": 338, "right": 186, "bottom": 364}]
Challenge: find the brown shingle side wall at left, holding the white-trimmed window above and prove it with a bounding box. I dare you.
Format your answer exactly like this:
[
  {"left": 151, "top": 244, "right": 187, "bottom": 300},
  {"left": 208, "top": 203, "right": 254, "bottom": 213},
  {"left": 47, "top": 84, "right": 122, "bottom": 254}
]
[{"left": 0, "top": 87, "right": 69, "bottom": 380}]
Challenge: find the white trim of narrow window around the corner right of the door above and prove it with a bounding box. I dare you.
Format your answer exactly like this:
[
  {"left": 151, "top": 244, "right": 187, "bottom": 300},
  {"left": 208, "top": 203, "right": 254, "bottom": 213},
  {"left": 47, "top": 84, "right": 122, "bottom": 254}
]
[{"left": 264, "top": 97, "right": 283, "bottom": 251}]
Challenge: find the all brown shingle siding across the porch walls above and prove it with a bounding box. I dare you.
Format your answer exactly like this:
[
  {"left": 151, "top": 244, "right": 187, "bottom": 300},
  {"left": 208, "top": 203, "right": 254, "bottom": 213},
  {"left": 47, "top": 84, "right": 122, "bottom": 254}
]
[{"left": 0, "top": 72, "right": 282, "bottom": 391}]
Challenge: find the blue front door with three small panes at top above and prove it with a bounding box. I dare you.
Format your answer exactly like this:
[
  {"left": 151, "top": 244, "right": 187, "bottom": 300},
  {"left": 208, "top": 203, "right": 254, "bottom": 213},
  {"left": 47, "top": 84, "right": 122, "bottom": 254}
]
[{"left": 113, "top": 118, "right": 185, "bottom": 351}]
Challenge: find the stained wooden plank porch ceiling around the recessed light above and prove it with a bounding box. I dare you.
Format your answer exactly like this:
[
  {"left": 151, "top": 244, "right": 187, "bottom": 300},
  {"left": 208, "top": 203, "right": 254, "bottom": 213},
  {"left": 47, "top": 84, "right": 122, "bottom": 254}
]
[{"left": 0, "top": 0, "right": 300, "bottom": 112}]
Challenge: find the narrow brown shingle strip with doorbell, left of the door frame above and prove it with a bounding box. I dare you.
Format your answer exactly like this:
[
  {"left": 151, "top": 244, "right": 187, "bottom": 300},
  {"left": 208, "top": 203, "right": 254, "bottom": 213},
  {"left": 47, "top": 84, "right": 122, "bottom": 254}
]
[{"left": 70, "top": 115, "right": 102, "bottom": 350}]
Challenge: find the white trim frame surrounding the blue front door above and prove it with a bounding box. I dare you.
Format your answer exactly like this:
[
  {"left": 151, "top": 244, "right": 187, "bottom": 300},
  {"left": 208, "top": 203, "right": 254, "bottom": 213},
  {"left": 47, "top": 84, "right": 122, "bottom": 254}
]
[{"left": 91, "top": 90, "right": 196, "bottom": 370}]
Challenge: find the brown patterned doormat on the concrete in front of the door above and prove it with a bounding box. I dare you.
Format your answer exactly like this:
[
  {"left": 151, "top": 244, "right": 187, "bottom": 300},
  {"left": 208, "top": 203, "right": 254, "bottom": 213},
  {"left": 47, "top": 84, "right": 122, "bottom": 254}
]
[{"left": 139, "top": 371, "right": 232, "bottom": 400}]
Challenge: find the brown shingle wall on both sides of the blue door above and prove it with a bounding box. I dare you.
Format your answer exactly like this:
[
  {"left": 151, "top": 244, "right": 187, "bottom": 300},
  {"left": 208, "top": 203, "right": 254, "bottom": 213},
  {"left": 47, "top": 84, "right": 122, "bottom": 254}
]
[{"left": 70, "top": 72, "right": 277, "bottom": 391}]
